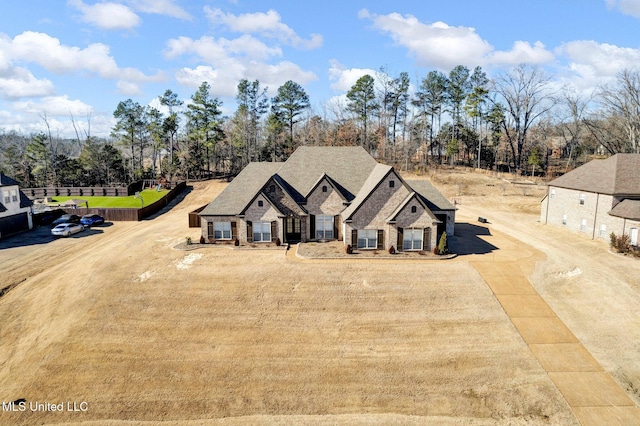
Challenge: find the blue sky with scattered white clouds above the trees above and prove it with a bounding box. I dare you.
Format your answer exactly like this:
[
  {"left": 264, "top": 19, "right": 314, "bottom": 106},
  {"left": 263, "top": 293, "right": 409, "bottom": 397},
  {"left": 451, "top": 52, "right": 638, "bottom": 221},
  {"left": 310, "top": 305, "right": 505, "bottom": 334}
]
[{"left": 0, "top": 0, "right": 640, "bottom": 138}]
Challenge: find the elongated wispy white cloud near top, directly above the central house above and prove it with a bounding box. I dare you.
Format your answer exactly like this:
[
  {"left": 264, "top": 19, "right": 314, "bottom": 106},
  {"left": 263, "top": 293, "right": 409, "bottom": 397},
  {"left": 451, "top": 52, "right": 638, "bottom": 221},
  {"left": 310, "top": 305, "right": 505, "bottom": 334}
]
[{"left": 204, "top": 6, "right": 323, "bottom": 49}]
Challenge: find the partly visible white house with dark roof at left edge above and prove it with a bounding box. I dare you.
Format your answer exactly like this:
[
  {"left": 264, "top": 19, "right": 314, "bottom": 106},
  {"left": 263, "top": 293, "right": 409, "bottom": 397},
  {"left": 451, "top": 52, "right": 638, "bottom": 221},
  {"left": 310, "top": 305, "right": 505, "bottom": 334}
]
[{"left": 0, "top": 173, "right": 33, "bottom": 238}]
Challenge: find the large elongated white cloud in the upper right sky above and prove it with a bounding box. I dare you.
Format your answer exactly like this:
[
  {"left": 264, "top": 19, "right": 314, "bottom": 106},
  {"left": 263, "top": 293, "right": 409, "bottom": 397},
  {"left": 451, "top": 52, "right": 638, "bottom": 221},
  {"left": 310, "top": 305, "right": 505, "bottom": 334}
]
[{"left": 358, "top": 9, "right": 554, "bottom": 70}]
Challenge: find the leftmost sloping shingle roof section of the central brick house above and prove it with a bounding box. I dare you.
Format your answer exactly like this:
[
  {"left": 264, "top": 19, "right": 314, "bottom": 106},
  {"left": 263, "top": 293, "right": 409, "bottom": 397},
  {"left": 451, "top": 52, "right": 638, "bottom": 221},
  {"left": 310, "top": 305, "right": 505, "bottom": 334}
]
[{"left": 200, "top": 163, "right": 282, "bottom": 216}]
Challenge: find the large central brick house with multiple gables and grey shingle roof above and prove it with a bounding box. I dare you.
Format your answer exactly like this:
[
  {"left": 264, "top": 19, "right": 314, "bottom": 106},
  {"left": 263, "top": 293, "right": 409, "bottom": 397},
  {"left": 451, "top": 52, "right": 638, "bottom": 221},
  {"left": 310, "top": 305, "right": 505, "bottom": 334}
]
[{"left": 200, "top": 147, "right": 455, "bottom": 250}]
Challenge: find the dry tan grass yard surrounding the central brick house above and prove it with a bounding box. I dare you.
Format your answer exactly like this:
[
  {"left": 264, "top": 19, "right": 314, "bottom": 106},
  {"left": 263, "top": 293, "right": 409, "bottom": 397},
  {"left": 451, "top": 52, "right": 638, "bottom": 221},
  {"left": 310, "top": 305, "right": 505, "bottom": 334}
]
[{"left": 0, "top": 168, "right": 640, "bottom": 425}]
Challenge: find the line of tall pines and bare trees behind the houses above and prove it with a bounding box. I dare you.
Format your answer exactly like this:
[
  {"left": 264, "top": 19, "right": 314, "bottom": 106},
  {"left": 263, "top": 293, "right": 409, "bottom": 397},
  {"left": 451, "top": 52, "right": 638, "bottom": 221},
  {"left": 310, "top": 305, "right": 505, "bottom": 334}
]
[{"left": 0, "top": 65, "right": 640, "bottom": 186}]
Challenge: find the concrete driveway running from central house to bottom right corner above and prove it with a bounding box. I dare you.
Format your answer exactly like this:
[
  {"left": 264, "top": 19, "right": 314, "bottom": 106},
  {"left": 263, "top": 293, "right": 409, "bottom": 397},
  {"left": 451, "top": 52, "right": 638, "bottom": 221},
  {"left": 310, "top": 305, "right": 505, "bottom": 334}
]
[{"left": 456, "top": 225, "right": 640, "bottom": 426}]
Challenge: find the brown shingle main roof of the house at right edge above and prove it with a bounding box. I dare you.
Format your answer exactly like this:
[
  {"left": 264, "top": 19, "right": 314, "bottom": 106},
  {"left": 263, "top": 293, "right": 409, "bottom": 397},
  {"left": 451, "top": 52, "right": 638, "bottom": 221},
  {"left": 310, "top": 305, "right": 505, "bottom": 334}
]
[{"left": 549, "top": 154, "right": 640, "bottom": 196}]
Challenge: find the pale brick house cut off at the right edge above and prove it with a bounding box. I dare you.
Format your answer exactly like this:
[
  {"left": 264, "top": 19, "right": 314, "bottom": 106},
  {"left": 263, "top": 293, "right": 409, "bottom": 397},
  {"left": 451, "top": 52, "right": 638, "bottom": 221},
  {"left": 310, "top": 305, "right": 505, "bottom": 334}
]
[{"left": 540, "top": 154, "right": 640, "bottom": 246}]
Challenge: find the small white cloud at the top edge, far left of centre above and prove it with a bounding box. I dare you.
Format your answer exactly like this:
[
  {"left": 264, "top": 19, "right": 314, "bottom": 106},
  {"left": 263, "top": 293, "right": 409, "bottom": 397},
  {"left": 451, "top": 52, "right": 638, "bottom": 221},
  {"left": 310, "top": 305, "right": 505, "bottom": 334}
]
[{"left": 67, "top": 0, "right": 141, "bottom": 30}]
